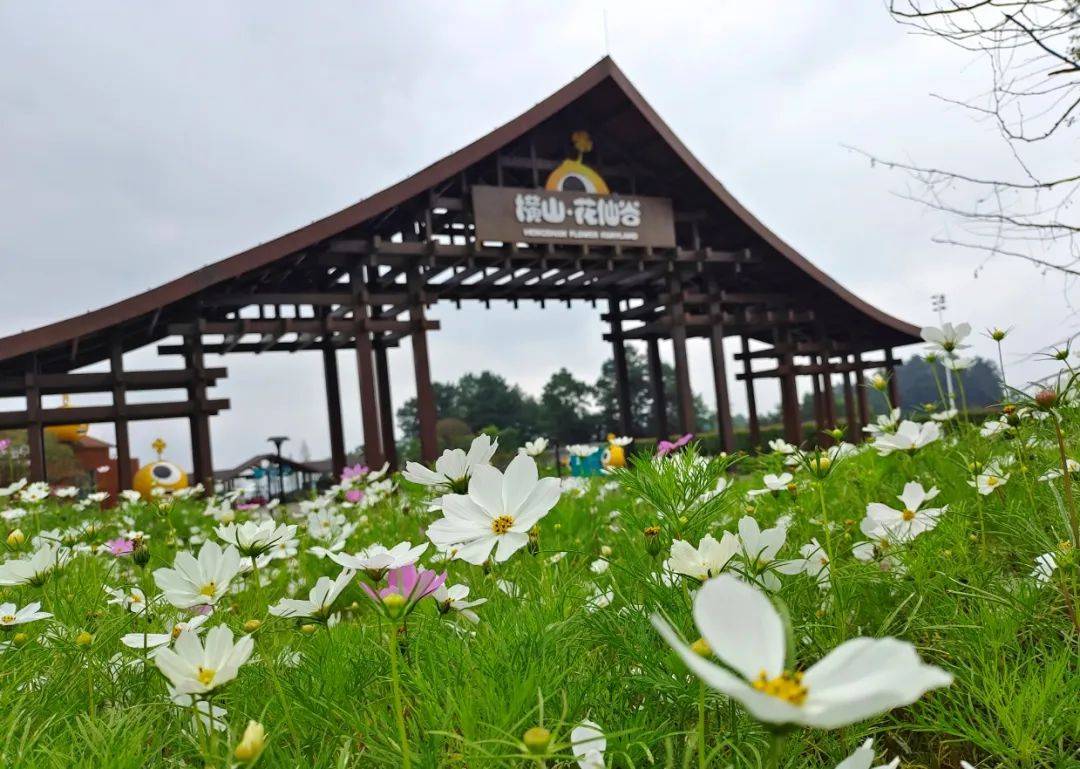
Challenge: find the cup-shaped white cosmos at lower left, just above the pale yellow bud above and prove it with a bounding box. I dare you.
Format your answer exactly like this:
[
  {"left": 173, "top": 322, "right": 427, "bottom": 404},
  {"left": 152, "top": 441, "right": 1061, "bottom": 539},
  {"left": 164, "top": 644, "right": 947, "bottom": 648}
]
[{"left": 153, "top": 625, "right": 255, "bottom": 694}]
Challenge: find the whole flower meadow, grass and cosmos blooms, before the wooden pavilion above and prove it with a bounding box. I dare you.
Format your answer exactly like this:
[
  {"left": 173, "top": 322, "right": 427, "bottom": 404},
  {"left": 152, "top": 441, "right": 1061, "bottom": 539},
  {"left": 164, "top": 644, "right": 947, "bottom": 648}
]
[{"left": 0, "top": 390, "right": 1080, "bottom": 769}]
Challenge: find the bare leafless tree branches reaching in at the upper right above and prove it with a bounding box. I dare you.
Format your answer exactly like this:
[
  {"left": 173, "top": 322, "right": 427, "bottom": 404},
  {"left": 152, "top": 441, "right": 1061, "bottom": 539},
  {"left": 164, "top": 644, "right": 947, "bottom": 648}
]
[{"left": 870, "top": 0, "right": 1080, "bottom": 275}]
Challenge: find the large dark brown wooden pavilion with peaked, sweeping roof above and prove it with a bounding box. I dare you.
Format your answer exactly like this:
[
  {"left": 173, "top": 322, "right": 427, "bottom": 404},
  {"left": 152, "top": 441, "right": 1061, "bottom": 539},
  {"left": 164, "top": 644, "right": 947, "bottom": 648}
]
[{"left": 0, "top": 57, "right": 918, "bottom": 488}]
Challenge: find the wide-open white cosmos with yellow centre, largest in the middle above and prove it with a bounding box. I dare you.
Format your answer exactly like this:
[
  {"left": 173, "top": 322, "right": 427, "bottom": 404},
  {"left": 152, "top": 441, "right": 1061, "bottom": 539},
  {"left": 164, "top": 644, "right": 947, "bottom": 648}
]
[{"left": 428, "top": 454, "right": 559, "bottom": 565}]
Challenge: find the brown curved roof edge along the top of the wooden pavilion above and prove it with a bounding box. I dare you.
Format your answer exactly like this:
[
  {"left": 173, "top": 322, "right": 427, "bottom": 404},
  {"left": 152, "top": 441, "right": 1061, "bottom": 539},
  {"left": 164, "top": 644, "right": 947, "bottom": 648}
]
[{"left": 0, "top": 56, "right": 919, "bottom": 361}]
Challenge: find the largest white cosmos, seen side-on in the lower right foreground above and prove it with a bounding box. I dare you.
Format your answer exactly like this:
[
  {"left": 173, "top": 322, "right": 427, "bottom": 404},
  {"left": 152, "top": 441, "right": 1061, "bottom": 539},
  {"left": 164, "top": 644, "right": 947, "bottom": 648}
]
[{"left": 652, "top": 575, "right": 953, "bottom": 729}]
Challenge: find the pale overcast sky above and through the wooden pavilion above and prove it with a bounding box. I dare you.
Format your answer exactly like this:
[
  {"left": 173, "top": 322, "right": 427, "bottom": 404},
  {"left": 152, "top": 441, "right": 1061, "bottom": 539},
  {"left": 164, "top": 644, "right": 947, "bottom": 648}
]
[{"left": 0, "top": 0, "right": 1077, "bottom": 467}]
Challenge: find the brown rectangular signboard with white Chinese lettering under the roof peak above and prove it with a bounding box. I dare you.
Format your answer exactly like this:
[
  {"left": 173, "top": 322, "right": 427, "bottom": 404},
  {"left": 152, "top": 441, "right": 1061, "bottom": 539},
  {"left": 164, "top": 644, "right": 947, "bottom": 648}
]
[{"left": 472, "top": 186, "right": 675, "bottom": 248}]
